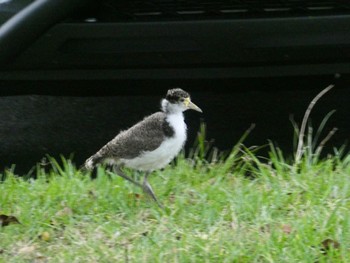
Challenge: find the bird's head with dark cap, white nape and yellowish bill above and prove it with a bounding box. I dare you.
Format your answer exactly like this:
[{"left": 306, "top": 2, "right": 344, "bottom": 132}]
[{"left": 162, "top": 88, "right": 202, "bottom": 113}]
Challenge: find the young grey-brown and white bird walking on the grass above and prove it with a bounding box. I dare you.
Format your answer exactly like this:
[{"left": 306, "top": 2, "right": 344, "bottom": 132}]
[{"left": 83, "top": 88, "right": 202, "bottom": 208}]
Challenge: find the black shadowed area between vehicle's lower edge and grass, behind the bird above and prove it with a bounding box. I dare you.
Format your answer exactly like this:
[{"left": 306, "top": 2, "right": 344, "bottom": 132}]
[{"left": 0, "top": 76, "right": 350, "bottom": 173}]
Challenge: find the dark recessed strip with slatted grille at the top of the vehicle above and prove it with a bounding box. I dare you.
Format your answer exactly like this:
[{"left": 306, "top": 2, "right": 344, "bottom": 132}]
[{"left": 74, "top": 0, "right": 350, "bottom": 22}]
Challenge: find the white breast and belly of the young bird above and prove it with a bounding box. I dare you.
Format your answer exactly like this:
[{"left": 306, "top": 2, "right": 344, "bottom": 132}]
[{"left": 120, "top": 112, "right": 187, "bottom": 171}]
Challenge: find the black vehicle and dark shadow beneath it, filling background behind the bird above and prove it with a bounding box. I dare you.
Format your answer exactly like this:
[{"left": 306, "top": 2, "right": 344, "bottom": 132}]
[{"left": 0, "top": 0, "right": 350, "bottom": 171}]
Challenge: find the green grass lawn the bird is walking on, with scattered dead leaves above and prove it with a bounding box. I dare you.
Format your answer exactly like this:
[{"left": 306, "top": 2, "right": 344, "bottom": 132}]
[{"left": 0, "top": 145, "right": 350, "bottom": 263}]
